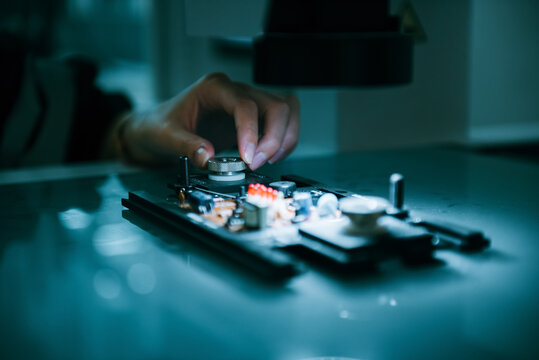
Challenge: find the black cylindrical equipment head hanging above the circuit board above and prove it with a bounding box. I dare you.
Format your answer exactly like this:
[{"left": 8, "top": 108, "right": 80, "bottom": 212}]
[{"left": 253, "top": 0, "right": 413, "bottom": 87}]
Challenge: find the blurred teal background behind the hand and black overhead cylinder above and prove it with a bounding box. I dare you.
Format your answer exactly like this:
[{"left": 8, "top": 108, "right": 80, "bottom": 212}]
[{"left": 0, "top": 0, "right": 539, "bottom": 158}]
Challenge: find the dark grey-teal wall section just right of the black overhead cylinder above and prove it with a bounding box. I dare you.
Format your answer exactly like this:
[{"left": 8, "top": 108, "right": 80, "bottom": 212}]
[{"left": 338, "top": 0, "right": 469, "bottom": 151}]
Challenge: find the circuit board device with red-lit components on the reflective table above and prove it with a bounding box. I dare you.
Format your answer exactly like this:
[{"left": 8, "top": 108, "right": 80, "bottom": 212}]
[{"left": 122, "top": 156, "right": 490, "bottom": 279}]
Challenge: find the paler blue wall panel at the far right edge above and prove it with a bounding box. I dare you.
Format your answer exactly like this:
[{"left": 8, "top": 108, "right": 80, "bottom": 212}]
[{"left": 469, "top": 0, "right": 539, "bottom": 143}]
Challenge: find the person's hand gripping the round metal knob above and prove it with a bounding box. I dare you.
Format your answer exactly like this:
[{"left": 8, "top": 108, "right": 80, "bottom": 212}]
[{"left": 109, "top": 73, "right": 299, "bottom": 170}]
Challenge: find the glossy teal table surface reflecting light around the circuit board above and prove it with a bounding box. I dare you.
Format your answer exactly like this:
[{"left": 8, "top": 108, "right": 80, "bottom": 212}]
[{"left": 0, "top": 149, "right": 539, "bottom": 359}]
